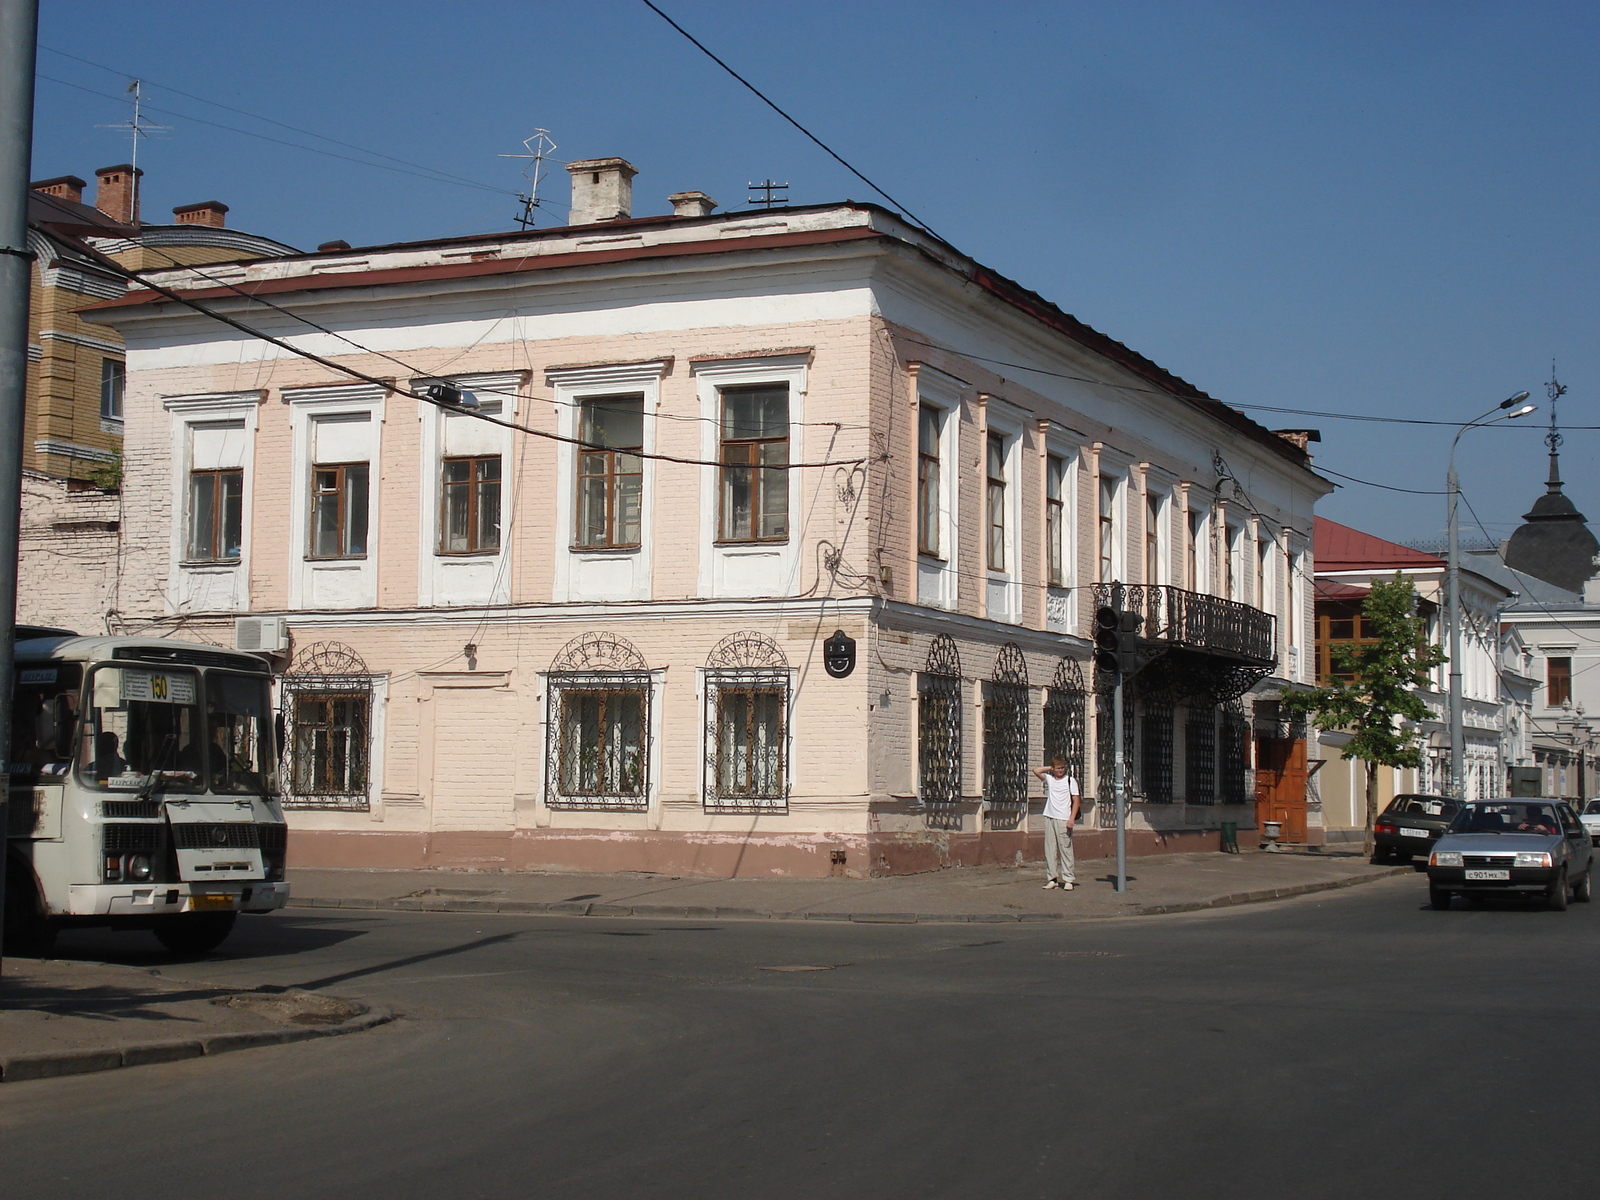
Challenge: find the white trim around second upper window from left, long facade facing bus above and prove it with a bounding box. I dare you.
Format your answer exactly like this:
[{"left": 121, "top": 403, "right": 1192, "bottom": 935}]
[{"left": 283, "top": 384, "right": 389, "bottom": 608}]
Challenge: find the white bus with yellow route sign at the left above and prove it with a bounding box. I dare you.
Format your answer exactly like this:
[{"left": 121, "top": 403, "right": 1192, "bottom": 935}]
[{"left": 5, "top": 627, "right": 290, "bottom": 954}]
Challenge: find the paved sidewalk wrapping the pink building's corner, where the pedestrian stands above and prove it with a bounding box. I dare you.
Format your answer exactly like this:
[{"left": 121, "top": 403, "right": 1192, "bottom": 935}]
[{"left": 290, "top": 850, "right": 1411, "bottom": 923}]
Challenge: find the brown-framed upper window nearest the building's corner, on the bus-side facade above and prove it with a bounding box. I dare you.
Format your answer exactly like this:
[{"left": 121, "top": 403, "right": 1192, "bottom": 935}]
[{"left": 717, "top": 386, "right": 789, "bottom": 542}]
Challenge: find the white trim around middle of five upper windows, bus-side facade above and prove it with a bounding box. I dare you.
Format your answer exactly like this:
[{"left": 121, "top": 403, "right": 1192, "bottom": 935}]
[{"left": 411, "top": 371, "right": 518, "bottom": 608}]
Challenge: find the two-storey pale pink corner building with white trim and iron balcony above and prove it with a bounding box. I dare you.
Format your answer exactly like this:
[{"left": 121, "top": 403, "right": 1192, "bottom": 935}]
[{"left": 84, "top": 158, "right": 1326, "bottom": 875}]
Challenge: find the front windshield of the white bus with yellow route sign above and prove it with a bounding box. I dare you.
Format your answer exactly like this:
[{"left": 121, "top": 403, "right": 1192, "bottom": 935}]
[{"left": 78, "top": 667, "right": 203, "bottom": 792}]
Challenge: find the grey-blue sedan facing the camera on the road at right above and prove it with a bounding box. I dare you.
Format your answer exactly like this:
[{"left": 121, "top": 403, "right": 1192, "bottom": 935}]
[{"left": 1427, "top": 798, "right": 1594, "bottom": 912}]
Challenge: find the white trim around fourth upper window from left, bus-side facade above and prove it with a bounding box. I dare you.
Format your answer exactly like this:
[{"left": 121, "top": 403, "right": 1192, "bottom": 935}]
[{"left": 544, "top": 358, "right": 670, "bottom": 603}]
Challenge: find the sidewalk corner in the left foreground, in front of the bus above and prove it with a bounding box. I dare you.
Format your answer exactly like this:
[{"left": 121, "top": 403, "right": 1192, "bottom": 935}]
[{"left": 0, "top": 958, "right": 390, "bottom": 1083}]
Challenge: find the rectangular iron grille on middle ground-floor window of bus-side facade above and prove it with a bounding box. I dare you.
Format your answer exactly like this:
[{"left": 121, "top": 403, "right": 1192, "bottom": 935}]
[{"left": 546, "top": 672, "right": 650, "bottom": 813}]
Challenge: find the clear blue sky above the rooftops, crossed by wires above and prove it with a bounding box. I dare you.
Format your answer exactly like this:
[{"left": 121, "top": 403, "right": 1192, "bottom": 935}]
[{"left": 34, "top": 0, "right": 1600, "bottom": 539}]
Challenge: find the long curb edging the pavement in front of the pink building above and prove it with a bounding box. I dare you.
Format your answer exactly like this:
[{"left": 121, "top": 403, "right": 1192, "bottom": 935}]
[{"left": 288, "top": 867, "right": 1413, "bottom": 925}]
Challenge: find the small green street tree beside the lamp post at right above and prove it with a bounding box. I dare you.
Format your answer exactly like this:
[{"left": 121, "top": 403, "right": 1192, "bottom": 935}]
[{"left": 1280, "top": 574, "right": 1448, "bottom": 854}]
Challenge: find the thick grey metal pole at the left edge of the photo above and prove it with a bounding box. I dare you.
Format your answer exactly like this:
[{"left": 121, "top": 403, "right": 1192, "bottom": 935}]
[{"left": 0, "top": 0, "right": 38, "bottom": 954}]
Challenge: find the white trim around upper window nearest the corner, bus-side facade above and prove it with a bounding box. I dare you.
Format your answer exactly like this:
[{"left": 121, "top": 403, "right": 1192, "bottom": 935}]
[{"left": 691, "top": 354, "right": 810, "bottom": 598}]
